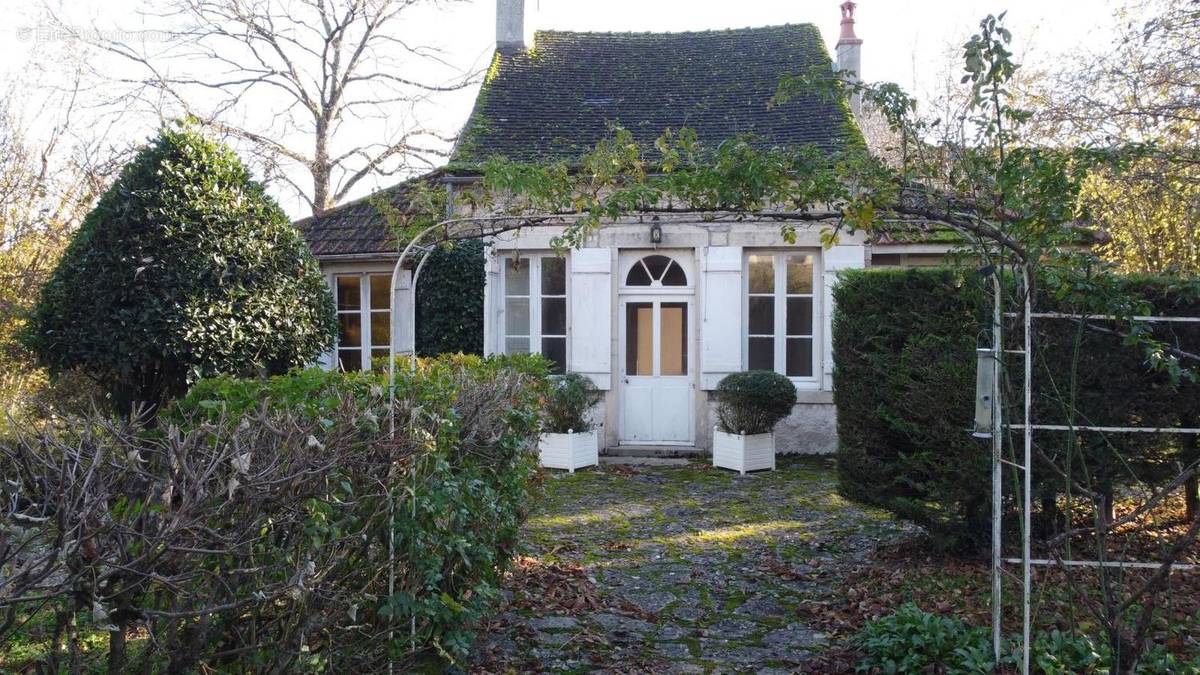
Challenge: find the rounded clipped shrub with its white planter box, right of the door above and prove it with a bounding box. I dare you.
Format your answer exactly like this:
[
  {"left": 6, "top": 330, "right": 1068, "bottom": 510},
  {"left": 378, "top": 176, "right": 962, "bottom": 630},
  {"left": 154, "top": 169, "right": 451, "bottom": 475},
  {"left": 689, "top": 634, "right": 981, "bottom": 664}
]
[{"left": 713, "top": 370, "right": 796, "bottom": 474}]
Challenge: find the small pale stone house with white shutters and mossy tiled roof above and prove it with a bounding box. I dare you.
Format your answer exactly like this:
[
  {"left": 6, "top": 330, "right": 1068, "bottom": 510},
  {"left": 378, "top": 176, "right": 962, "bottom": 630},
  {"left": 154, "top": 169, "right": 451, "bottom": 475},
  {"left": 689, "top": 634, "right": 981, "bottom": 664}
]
[{"left": 298, "top": 0, "right": 947, "bottom": 453}]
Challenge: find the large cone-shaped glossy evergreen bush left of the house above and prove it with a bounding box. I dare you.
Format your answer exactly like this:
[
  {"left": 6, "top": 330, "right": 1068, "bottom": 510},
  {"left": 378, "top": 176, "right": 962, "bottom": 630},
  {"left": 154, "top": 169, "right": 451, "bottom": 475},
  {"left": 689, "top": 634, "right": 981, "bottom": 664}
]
[{"left": 26, "top": 124, "right": 335, "bottom": 411}]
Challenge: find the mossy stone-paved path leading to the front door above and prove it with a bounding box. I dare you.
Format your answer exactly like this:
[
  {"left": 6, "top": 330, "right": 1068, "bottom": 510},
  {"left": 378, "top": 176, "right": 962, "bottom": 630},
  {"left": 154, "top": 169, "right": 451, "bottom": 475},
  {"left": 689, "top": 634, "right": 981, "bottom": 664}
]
[{"left": 472, "top": 458, "right": 906, "bottom": 673}]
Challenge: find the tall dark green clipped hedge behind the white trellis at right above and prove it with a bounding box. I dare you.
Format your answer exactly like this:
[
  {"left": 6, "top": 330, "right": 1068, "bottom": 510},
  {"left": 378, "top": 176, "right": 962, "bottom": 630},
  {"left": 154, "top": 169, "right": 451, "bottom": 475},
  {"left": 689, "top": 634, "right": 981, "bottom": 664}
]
[{"left": 833, "top": 269, "right": 1200, "bottom": 550}]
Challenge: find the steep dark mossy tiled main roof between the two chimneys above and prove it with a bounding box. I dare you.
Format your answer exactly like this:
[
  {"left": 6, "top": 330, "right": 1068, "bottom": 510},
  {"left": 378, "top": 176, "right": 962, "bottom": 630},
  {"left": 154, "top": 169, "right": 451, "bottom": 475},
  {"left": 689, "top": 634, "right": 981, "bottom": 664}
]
[{"left": 451, "top": 24, "right": 850, "bottom": 169}]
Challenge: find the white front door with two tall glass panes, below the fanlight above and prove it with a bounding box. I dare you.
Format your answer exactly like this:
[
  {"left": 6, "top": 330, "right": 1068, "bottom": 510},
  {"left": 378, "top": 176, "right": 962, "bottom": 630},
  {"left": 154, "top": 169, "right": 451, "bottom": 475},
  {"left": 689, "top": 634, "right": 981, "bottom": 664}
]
[{"left": 620, "top": 295, "right": 695, "bottom": 444}]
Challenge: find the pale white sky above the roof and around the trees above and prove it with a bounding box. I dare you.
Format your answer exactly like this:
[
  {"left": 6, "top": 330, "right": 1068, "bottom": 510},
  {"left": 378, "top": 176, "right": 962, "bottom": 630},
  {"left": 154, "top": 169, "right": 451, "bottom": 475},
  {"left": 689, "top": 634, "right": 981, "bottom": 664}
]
[{"left": 0, "top": 0, "right": 1114, "bottom": 215}]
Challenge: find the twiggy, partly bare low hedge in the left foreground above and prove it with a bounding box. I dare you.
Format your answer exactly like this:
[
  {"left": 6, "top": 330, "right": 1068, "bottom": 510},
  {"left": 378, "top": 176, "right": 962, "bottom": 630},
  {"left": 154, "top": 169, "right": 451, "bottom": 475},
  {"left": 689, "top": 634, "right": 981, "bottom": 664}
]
[{"left": 0, "top": 357, "right": 546, "bottom": 673}]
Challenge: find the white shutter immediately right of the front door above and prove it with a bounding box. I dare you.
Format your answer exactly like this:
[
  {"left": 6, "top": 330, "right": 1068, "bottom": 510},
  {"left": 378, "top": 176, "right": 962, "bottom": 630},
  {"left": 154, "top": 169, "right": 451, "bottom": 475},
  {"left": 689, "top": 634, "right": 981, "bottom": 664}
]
[{"left": 700, "top": 246, "right": 742, "bottom": 389}]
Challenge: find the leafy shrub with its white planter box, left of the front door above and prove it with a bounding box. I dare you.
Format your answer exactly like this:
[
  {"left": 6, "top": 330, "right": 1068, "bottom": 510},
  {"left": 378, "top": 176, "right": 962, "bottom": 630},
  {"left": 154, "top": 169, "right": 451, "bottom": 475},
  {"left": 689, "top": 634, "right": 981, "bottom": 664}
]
[{"left": 538, "top": 372, "right": 604, "bottom": 473}]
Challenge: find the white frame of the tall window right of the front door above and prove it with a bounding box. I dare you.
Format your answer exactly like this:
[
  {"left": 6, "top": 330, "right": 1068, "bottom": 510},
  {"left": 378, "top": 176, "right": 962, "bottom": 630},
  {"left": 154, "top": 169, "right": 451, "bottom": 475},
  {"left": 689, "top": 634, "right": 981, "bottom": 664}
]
[{"left": 742, "top": 249, "right": 822, "bottom": 389}]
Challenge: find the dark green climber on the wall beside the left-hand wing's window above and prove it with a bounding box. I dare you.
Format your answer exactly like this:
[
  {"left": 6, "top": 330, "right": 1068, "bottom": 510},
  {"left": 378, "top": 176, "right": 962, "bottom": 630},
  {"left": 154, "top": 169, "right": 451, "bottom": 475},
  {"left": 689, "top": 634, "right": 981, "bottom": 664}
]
[{"left": 416, "top": 240, "right": 485, "bottom": 357}]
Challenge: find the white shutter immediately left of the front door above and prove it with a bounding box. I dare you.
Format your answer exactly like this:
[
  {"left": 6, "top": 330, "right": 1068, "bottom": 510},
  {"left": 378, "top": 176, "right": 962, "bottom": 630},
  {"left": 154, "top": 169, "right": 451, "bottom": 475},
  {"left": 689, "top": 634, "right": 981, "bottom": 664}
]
[{"left": 566, "top": 249, "right": 612, "bottom": 389}]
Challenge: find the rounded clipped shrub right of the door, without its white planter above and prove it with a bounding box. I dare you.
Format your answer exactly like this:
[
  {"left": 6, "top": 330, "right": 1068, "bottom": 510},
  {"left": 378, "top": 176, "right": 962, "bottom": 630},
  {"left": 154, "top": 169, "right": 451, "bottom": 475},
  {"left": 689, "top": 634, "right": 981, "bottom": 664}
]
[{"left": 713, "top": 370, "right": 796, "bottom": 434}]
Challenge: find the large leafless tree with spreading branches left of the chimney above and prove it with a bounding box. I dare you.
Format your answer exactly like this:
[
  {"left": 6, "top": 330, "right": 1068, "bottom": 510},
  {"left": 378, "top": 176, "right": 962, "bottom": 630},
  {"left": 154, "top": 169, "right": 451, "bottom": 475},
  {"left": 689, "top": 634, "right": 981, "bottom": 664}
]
[{"left": 84, "top": 0, "right": 474, "bottom": 215}]
